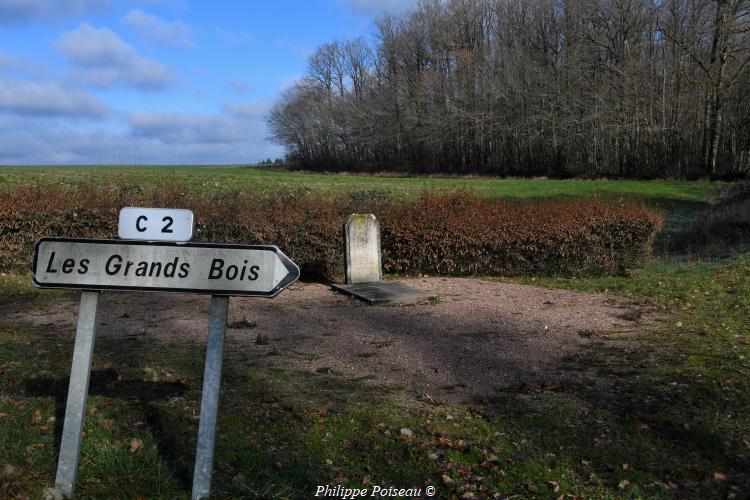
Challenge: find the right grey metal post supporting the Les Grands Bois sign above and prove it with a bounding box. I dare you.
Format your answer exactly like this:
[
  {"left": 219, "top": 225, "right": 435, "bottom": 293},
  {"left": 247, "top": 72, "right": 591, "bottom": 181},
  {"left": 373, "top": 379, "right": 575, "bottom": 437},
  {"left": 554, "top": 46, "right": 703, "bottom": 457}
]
[{"left": 192, "top": 296, "right": 229, "bottom": 500}]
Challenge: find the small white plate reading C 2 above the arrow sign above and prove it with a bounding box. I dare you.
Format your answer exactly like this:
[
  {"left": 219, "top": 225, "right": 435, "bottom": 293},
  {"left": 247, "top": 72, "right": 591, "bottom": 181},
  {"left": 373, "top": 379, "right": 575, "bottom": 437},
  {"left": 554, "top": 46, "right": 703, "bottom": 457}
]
[{"left": 117, "top": 207, "right": 193, "bottom": 241}]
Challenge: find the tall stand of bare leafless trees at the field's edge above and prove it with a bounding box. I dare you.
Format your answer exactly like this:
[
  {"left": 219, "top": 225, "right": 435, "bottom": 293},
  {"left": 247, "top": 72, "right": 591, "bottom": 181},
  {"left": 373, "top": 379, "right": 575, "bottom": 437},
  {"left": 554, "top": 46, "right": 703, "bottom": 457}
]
[{"left": 266, "top": 0, "right": 750, "bottom": 178}]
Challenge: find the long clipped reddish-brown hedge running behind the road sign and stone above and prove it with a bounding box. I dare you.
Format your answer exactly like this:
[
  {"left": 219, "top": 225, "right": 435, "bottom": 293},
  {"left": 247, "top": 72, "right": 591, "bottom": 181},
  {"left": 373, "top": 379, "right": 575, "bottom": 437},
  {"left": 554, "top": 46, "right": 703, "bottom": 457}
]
[{"left": 0, "top": 183, "right": 661, "bottom": 281}]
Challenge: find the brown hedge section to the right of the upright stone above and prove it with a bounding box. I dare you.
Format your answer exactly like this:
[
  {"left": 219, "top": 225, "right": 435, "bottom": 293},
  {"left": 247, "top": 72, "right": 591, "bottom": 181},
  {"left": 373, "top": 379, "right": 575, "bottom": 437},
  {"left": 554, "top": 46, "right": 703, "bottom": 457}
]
[{"left": 381, "top": 192, "right": 661, "bottom": 276}]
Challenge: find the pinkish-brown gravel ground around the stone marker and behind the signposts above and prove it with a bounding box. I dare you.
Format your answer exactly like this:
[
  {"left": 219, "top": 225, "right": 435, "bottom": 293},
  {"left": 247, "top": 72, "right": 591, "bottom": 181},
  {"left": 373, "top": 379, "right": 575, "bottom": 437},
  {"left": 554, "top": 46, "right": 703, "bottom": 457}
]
[{"left": 7, "top": 278, "right": 659, "bottom": 402}]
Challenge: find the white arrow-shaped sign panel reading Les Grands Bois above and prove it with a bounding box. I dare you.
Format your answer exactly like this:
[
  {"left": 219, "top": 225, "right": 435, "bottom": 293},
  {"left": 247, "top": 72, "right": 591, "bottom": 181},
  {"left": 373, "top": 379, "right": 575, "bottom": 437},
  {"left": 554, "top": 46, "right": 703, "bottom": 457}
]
[{"left": 34, "top": 238, "right": 299, "bottom": 297}]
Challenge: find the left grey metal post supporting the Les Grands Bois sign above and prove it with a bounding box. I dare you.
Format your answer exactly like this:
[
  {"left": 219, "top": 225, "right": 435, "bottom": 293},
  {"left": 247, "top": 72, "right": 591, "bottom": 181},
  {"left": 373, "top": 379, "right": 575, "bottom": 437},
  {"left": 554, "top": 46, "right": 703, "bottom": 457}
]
[{"left": 55, "top": 291, "right": 99, "bottom": 496}]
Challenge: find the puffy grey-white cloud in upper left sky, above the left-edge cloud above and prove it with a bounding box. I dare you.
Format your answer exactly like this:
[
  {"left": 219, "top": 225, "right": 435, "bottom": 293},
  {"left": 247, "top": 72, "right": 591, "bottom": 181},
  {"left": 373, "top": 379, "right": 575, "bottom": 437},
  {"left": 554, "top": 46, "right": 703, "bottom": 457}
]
[{"left": 57, "top": 23, "right": 175, "bottom": 90}]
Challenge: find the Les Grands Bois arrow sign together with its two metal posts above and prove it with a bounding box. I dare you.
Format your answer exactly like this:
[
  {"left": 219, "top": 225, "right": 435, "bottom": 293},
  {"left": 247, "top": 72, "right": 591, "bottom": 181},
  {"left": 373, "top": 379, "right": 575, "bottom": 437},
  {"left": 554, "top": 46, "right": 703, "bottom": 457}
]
[{"left": 33, "top": 233, "right": 299, "bottom": 499}]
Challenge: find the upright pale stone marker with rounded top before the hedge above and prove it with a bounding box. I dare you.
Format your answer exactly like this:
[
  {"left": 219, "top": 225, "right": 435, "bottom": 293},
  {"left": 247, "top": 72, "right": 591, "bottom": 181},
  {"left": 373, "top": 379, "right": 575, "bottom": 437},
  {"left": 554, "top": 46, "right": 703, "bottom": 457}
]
[{"left": 344, "top": 214, "right": 383, "bottom": 285}]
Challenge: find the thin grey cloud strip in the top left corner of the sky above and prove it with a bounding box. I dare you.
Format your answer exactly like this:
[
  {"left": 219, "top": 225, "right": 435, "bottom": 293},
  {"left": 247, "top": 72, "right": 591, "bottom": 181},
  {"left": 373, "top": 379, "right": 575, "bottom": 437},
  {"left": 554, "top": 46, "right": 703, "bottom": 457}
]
[{"left": 0, "top": 0, "right": 112, "bottom": 25}]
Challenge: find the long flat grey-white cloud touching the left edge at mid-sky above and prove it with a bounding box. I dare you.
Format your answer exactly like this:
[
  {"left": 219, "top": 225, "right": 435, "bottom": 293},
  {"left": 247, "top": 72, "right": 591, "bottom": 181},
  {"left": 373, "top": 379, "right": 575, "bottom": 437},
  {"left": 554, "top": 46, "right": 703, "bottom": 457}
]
[{"left": 0, "top": 78, "right": 110, "bottom": 118}]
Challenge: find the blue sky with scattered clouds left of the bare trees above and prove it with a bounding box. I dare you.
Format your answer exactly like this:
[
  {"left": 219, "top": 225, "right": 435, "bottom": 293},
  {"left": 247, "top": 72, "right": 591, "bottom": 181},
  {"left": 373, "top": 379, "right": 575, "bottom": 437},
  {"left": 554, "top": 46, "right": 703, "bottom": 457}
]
[{"left": 0, "top": 0, "right": 413, "bottom": 165}]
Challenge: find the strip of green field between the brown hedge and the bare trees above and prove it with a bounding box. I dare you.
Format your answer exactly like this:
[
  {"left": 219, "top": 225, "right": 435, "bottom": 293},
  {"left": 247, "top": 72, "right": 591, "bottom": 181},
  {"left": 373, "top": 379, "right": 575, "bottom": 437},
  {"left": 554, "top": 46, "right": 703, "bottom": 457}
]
[{"left": 0, "top": 166, "right": 723, "bottom": 203}]
